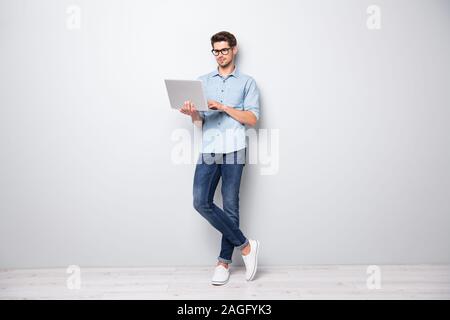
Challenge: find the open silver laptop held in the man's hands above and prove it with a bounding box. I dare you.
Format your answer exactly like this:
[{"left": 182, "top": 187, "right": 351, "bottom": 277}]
[{"left": 164, "top": 79, "right": 217, "bottom": 111}]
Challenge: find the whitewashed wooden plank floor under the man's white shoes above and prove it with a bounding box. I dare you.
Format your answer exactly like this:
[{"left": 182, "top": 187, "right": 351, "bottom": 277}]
[{"left": 0, "top": 265, "right": 450, "bottom": 300}]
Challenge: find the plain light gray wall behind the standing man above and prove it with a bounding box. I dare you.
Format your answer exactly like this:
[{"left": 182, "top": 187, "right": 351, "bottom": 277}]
[{"left": 0, "top": 0, "right": 450, "bottom": 268}]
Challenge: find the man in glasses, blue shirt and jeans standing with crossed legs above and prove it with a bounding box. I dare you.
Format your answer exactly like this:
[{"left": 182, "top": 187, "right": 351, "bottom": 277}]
[{"left": 180, "top": 31, "right": 259, "bottom": 285}]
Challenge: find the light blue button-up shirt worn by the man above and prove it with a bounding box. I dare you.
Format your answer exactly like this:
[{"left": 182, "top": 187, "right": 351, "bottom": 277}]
[{"left": 197, "top": 66, "right": 259, "bottom": 153}]
